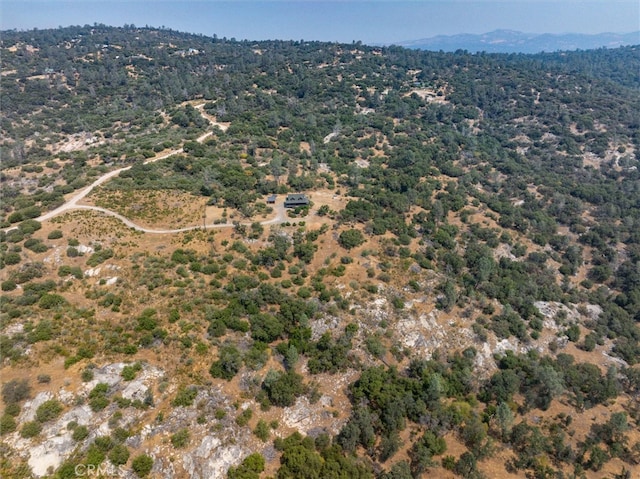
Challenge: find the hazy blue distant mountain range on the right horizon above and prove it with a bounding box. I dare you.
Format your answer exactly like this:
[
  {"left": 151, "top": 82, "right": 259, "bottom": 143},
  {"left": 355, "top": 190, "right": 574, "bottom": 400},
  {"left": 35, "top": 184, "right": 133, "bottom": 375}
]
[{"left": 398, "top": 30, "right": 640, "bottom": 53}]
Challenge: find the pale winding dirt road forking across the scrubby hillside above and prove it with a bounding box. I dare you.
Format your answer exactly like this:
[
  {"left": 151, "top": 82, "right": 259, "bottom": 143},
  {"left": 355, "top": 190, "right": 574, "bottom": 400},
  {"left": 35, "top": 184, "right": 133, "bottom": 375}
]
[{"left": 25, "top": 104, "right": 287, "bottom": 234}]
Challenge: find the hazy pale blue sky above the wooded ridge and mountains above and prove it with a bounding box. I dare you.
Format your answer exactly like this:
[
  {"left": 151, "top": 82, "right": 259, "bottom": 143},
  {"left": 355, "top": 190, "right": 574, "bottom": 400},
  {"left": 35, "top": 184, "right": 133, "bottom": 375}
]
[{"left": 0, "top": 0, "right": 640, "bottom": 44}]
